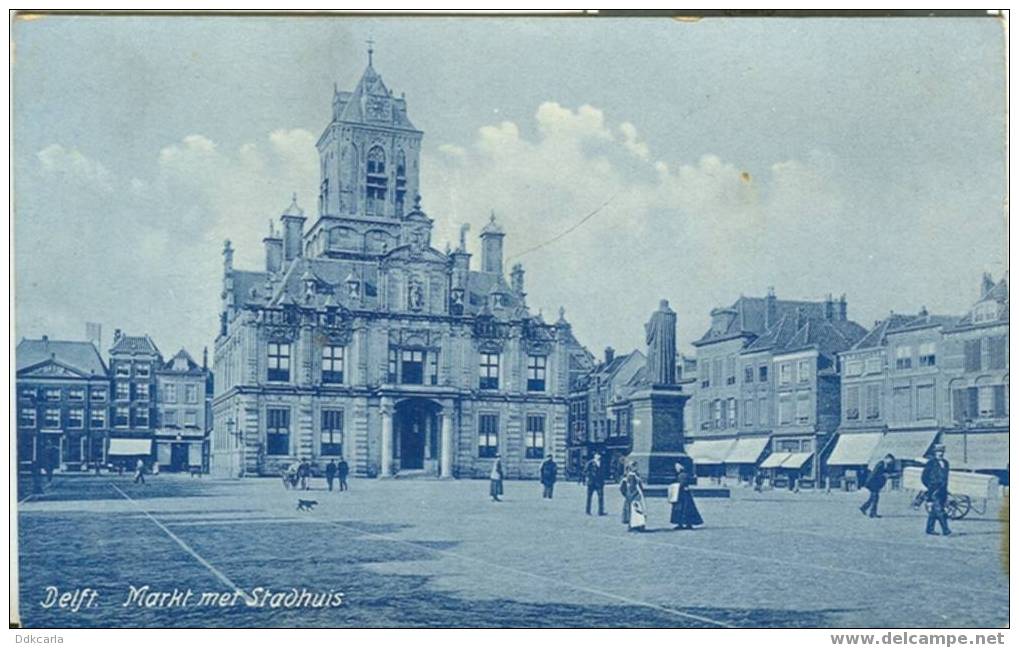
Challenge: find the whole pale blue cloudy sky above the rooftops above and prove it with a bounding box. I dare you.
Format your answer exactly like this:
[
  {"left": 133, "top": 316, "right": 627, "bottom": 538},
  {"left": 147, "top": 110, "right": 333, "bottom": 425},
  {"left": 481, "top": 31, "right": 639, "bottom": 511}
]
[{"left": 12, "top": 16, "right": 1007, "bottom": 358}]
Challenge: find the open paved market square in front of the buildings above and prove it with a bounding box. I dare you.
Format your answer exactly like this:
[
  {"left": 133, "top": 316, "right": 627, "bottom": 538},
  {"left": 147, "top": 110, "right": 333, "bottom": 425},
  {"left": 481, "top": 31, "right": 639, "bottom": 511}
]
[{"left": 18, "top": 475, "right": 1009, "bottom": 628}]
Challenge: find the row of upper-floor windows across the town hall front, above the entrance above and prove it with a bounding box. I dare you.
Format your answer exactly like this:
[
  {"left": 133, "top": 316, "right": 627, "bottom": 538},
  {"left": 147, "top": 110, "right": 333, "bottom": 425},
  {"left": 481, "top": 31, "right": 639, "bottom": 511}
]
[{"left": 268, "top": 342, "right": 548, "bottom": 391}]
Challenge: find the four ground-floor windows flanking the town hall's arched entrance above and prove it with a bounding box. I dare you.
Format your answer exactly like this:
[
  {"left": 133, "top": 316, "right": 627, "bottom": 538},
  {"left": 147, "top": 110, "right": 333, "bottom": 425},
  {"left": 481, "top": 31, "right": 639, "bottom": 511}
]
[{"left": 258, "top": 408, "right": 545, "bottom": 458}]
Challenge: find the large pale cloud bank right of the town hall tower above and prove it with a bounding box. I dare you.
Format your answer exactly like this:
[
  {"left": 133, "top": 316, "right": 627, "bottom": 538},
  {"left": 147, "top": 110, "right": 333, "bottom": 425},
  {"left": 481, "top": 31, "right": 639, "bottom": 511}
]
[{"left": 422, "top": 102, "right": 845, "bottom": 348}]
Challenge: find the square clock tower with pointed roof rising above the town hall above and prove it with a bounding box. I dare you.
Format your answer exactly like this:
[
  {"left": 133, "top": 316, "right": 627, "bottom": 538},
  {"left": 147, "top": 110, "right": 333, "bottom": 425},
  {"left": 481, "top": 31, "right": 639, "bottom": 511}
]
[{"left": 318, "top": 43, "right": 423, "bottom": 222}]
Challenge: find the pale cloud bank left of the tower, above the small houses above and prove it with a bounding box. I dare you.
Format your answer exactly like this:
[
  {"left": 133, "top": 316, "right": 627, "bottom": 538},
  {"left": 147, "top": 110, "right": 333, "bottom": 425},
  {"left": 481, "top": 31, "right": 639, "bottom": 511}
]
[{"left": 15, "top": 129, "right": 318, "bottom": 353}]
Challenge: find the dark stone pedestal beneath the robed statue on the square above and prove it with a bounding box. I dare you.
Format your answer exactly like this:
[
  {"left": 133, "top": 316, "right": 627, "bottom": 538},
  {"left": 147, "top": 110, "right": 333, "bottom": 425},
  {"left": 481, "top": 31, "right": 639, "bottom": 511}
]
[{"left": 628, "top": 385, "right": 691, "bottom": 485}]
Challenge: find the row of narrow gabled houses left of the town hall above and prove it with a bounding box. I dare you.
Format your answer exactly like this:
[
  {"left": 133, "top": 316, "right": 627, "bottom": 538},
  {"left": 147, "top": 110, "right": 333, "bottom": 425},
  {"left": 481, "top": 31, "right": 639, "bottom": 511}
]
[{"left": 15, "top": 330, "right": 212, "bottom": 471}]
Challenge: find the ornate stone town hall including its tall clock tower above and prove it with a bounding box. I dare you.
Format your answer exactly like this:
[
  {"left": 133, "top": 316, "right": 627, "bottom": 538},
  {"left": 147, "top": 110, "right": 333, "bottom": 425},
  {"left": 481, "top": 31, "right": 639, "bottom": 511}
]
[{"left": 211, "top": 51, "right": 593, "bottom": 479}]
